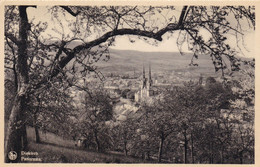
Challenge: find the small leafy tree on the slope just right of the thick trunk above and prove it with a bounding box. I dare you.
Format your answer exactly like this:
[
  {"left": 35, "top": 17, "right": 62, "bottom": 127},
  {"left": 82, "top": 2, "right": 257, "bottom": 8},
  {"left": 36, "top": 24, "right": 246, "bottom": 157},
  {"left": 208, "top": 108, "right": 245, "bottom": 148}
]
[{"left": 26, "top": 80, "right": 75, "bottom": 143}]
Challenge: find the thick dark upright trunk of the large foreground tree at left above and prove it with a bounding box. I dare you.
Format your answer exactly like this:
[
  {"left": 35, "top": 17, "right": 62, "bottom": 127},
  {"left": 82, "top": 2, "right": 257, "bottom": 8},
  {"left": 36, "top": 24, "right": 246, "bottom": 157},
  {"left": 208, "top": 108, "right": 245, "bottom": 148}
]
[{"left": 5, "top": 6, "right": 29, "bottom": 163}]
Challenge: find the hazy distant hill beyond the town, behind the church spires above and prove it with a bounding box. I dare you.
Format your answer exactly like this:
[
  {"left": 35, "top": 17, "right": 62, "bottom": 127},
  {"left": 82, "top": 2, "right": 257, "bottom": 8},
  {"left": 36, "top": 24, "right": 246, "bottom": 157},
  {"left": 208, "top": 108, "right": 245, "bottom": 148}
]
[{"left": 96, "top": 49, "right": 218, "bottom": 78}]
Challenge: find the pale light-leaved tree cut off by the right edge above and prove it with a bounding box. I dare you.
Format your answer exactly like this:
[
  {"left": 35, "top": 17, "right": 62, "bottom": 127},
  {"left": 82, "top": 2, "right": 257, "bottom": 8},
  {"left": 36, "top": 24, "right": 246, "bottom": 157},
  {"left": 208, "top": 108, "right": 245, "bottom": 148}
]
[{"left": 228, "top": 67, "right": 255, "bottom": 164}]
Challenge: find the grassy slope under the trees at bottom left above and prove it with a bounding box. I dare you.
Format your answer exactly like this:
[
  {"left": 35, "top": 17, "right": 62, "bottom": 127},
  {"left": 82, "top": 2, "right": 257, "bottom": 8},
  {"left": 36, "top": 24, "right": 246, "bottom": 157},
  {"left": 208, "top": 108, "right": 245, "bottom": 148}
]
[{"left": 27, "top": 127, "right": 153, "bottom": 163}]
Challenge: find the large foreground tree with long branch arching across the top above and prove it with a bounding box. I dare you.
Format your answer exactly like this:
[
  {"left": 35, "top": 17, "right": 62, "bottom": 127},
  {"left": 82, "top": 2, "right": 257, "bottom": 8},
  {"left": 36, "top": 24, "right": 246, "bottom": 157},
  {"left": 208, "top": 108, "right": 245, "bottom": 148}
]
[{"left": 5, "top": 6, "right": 255, "bottom": 162}]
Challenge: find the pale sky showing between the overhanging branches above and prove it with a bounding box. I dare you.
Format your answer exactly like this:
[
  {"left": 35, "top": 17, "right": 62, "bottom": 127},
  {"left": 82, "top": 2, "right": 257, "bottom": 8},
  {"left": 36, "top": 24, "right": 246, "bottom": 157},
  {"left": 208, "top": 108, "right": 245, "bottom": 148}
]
[{"left": 28, "top": 6, "right": 255, "bottom": 57}]
